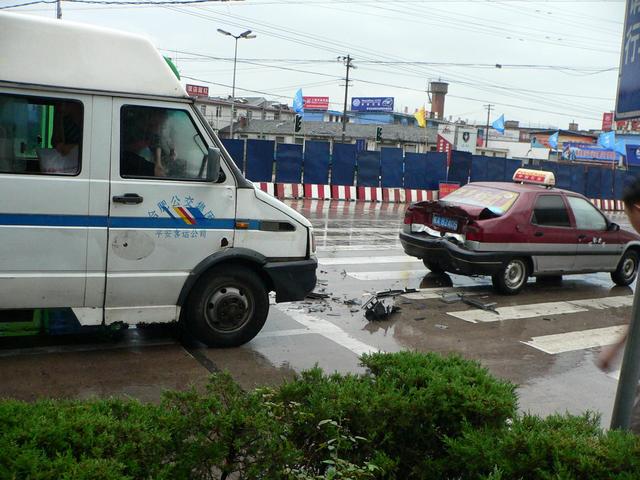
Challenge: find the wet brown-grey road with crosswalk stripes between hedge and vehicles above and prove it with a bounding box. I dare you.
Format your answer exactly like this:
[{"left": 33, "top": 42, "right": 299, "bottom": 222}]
[{"left": 0, "top": 200, "right": 633, "bottom": 426}]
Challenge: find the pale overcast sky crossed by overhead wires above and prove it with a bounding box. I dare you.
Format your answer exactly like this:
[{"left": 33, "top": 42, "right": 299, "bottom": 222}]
[{"left": 0, "top": 0, "right": 625, "bottom": 128}]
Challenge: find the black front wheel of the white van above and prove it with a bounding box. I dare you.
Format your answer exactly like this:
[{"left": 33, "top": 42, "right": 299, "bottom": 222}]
[{"left": 185, "top": 267, "right": 269, "bottom": 347}]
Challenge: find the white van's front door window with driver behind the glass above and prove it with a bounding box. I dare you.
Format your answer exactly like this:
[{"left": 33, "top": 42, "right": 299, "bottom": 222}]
[{"left": 120, "top": 105, "right": 207, "bottom": 180}]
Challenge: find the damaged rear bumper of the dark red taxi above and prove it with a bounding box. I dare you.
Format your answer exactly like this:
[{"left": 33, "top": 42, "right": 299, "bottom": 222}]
[{"left": 400, "top": 231, "right": 511, "bottom": 275}]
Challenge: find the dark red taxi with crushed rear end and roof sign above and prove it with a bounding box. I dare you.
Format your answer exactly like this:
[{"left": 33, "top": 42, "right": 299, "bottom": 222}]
[{"left": 400, "top": 169, "right": 640, "bottom": 294}]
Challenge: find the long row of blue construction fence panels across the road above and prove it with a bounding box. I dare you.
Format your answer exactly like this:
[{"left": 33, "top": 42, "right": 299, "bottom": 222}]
[{"left": 222, "top": 139, "right": 640, "bottom": 200}]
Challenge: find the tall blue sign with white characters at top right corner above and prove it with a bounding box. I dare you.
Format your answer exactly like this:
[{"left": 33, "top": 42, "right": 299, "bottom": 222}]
[{"left": 616, "top": 0, "right": 640, "bottom": 120}]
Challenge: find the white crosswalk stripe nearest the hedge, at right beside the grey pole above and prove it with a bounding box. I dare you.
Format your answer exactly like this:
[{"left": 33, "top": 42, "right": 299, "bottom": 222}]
[{"left": 521, "top": 325, "right": 627, "bottom": 355}]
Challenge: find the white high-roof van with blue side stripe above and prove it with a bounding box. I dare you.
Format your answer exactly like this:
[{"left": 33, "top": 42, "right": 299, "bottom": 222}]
[{"left": 0, "top": 13, "right": 317, "bottom": 347}]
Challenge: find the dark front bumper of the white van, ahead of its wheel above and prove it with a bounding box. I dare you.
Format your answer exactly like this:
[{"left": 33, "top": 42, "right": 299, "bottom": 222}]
[{"left": 264, "top": 257, "right": 318, "bottom": 303}]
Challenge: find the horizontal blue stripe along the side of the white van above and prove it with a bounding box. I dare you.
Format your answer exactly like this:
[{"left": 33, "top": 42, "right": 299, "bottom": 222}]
[{"left": 0, "top": 213, "right": 254, "bottom": 230}]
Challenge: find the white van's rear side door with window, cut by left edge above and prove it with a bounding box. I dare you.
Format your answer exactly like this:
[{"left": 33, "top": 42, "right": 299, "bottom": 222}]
[{"left": 0, "top": 89, "right": 90, "bottom": 308}]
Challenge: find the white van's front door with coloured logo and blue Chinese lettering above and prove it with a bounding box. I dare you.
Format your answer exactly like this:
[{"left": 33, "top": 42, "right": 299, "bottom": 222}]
[{"left": 105, "top": 99, "right": 236, "bottom": 324}]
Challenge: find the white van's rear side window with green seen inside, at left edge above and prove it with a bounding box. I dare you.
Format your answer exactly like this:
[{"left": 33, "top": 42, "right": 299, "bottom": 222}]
[{"left": 0, "top": 94, "right": 84, "bottom": 175}]
